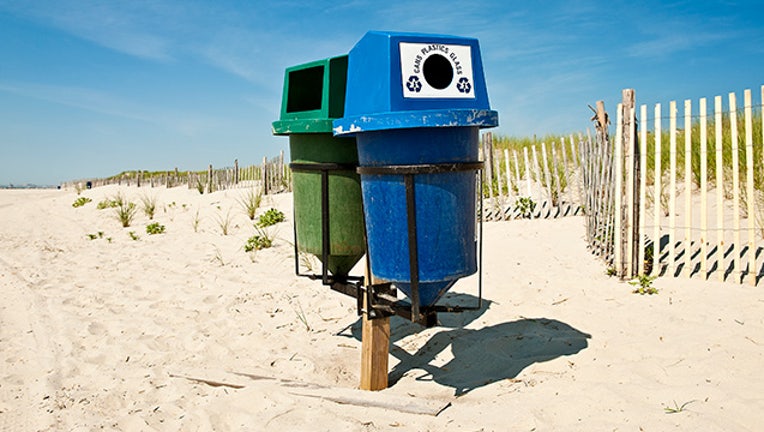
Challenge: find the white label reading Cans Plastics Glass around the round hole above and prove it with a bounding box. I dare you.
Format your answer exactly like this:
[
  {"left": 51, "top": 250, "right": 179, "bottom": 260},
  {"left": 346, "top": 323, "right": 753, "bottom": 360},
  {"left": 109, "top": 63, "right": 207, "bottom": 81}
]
[{"left": 398, "top": 42, "right": 475, "bottom": 99}]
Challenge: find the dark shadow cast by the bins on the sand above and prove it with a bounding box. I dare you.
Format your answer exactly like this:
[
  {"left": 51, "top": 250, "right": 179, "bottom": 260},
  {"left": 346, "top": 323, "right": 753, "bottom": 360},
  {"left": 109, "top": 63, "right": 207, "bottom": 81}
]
[{"left": 340, "top": 293, "right": 591, "bottom": 396}]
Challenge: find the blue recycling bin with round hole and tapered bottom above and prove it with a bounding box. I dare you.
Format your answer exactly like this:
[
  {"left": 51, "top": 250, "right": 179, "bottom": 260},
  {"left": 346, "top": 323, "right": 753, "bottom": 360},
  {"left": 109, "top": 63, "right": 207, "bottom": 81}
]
[{"left": 333, "top": 31, "right": 498, "bottom": 307}]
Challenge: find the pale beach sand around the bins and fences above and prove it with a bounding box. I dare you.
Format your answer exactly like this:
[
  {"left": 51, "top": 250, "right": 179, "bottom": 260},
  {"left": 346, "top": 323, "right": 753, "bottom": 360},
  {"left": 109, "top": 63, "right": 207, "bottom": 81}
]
[{"left": 0, "top": 186, "right": 764, "bottom": 432}]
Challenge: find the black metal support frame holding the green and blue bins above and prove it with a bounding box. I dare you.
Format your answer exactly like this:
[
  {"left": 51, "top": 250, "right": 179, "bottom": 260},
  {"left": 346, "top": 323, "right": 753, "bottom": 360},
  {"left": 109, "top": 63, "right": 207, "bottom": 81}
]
[{"left": 289, "top": 162, "right": 483, "bottom": 327}]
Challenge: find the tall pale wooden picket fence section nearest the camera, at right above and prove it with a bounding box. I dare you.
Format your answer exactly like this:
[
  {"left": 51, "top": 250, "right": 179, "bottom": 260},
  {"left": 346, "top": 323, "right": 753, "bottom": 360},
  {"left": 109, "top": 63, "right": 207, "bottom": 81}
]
[{"left": 583, "top": 86, "right": 764, "bottom": 285}]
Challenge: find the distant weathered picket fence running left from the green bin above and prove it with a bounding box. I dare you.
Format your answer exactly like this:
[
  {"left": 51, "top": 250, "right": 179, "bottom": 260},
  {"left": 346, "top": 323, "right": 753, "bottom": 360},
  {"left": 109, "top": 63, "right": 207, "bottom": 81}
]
[{"left": 61, "top": 151, "right": 292, "bottom": 194}]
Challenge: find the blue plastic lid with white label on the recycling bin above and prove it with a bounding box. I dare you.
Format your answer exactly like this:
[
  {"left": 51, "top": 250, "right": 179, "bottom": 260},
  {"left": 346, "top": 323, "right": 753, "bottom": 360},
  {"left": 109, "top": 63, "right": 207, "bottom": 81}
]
[{"left": 333, "top": 31, "right": 498, "bottom": 135}]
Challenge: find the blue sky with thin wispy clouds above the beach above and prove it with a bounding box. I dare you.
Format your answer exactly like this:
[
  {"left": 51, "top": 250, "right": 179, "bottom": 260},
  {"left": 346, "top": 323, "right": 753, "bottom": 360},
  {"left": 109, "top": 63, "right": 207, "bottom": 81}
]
[{"left": 0, "top": 0, "right": 764, "bottom": 185}]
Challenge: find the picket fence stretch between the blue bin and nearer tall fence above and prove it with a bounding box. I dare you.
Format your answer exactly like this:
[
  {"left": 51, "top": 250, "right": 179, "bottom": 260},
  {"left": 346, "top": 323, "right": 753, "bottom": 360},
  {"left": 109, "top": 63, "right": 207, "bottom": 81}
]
[{"left": 481, "top": 132, "right": 585, "bottom": 221}]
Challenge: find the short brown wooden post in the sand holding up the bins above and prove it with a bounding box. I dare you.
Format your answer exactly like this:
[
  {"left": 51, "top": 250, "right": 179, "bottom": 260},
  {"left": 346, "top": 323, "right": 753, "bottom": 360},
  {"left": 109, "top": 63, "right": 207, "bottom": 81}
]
[{"left": 361, "top": 258, "right": 390, "bottom": 391}]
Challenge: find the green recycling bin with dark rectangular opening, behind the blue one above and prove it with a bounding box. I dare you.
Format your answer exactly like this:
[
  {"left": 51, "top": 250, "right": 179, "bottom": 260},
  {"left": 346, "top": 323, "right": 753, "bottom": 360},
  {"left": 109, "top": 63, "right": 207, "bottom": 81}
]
[{"left": 273, "top": 55, "right": 366, "bottom": 282}]
